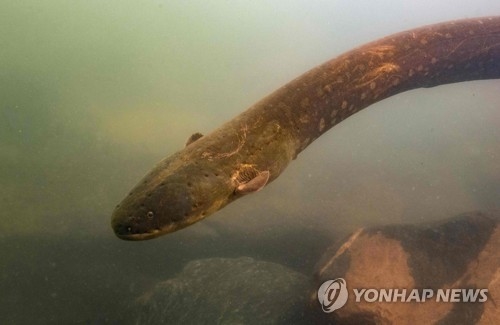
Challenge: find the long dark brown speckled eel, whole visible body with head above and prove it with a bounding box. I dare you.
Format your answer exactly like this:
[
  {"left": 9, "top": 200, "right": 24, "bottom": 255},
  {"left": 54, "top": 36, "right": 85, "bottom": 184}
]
[{"left": 111, "top": 17, "right": 500, "bottom": 240}]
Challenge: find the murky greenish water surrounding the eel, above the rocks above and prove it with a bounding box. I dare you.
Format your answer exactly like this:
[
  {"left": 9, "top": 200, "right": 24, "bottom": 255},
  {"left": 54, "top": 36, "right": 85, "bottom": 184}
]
[{"left": 0, "top": 0, "right": 500, "bottom": 324}]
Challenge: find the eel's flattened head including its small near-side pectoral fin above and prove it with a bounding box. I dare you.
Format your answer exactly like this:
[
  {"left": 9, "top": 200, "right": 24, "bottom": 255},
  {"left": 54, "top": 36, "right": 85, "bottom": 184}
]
[{"left": 111, "top": 159, "right": 269, "bottom": 240}]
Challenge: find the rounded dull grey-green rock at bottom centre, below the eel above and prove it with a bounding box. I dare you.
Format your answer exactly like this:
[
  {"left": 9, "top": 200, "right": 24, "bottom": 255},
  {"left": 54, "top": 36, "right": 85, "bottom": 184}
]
[{"left": 137, "top": 257, "right": 309, "bottom": 324}]
